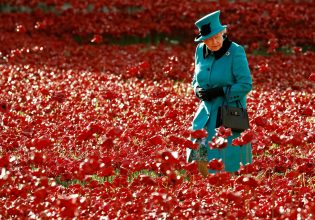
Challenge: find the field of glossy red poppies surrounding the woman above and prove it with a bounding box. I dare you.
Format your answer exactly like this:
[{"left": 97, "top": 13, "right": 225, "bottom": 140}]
[{"left": 0, "top": 0, "right": 315, "bottom": 219}]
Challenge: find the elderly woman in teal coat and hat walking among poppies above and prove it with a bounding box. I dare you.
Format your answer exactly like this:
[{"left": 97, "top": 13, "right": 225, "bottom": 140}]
[{"left": 187, "top": 11, "right": 252, "bottom": 176}]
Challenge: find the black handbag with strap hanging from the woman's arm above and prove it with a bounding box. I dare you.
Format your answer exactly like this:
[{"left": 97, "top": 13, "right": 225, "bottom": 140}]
[{"left": 216, "top": 87, "right": 249, "bottom": 132}]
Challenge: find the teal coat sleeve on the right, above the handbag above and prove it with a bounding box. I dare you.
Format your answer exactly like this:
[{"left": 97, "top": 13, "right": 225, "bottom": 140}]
[{"left": 225, "top": 46, "right": 252, "bottom": 102}]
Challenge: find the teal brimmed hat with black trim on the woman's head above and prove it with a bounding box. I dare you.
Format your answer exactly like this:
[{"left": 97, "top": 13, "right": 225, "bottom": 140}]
[{"left": 195, "top": 11, "right": 226, "bottom": 42}]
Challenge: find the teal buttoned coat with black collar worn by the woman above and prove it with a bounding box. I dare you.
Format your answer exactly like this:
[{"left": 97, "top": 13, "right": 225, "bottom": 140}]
[{"left": 187, "top": 38, "right": 252, "bottom": 173}]
